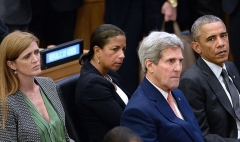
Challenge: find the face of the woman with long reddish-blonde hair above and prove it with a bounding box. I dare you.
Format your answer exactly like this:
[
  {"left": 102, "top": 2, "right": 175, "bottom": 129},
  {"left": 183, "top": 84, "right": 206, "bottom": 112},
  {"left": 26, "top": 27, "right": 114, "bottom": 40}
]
[{"left": 11, "top": 41, "right": 41, "bottom": 78}]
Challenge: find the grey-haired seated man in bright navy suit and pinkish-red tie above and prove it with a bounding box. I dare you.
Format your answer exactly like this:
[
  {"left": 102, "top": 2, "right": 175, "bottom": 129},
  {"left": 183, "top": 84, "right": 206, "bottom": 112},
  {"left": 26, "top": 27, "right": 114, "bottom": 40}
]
[{"left": 120, "top": 31, "right": 204, "bottom": 142}]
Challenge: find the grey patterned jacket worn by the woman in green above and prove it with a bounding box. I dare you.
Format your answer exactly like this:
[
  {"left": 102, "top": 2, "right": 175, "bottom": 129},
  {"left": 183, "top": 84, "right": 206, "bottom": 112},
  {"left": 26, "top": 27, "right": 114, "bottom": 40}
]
[{"left": 0, "top": 77, "right": 70, "bottom": 142}]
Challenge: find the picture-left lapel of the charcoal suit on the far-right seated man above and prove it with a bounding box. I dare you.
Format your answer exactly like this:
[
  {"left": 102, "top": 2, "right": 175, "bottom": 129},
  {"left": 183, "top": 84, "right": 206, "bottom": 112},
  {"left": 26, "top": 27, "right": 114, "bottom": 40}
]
[{"left": 197, "top": 57, "right": 235, "bottom": 118}]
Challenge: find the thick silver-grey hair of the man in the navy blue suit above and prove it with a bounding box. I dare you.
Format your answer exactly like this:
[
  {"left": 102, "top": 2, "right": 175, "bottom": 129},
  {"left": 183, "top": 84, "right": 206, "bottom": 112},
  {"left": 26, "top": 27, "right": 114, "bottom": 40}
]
[{"left": 138, "top": 31, "right": 184, "bottom": 73}]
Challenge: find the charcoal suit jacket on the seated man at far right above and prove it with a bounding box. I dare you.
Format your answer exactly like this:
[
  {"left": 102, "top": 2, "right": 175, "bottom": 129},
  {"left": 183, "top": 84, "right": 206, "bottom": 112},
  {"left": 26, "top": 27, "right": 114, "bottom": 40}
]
[{"left": 179, "top": 57, "right": 240, "bottom": 142}]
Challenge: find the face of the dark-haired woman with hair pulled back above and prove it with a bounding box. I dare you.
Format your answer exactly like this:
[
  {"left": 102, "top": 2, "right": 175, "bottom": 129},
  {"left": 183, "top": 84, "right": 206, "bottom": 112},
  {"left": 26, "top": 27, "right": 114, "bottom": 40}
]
[{"left": 99, "top": 35, "right": 126, "bottom": 71}]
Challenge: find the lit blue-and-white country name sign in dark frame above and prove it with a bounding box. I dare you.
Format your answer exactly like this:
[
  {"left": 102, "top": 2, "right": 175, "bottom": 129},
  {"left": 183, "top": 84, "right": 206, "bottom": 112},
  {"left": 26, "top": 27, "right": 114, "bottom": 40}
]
[{"left": 40, "top": 39, "right": 83, "bottom": 70}]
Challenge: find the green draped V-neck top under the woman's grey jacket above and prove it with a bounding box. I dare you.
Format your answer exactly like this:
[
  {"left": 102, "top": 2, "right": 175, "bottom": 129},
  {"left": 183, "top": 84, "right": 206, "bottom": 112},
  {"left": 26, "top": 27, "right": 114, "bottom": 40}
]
[{"left": 23, "top": 89, "right": 66, "bottom": 142}]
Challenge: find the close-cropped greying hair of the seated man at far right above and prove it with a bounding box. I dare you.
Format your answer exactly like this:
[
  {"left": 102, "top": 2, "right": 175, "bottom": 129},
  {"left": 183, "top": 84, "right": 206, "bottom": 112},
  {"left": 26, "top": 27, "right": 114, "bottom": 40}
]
[{"left": 191, "top": 15, "right": 226, "bottom": 41}]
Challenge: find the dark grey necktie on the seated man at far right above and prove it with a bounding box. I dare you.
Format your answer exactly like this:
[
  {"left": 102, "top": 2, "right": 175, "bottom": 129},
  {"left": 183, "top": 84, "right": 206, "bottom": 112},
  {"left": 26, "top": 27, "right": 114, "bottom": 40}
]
[{"left": 221, "top": 69, "right": 240, "bottom": 120}]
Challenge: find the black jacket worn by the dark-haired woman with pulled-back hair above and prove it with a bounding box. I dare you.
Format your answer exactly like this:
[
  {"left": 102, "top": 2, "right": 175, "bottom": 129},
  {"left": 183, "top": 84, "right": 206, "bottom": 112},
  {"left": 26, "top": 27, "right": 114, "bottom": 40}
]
[{"left": 75, "top": 61, "right": 130, "bottom": 142}]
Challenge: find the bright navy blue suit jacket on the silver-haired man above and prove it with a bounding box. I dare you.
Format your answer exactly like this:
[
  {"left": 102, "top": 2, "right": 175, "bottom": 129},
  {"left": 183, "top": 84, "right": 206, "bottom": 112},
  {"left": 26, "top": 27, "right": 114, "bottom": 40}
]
[{"left": 121, "top": 78, "right": 203, "bottom": 142}]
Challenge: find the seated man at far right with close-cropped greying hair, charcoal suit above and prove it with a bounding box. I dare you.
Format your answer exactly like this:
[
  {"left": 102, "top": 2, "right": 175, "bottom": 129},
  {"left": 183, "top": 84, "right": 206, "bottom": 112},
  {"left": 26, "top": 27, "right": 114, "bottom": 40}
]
[{"left": 178, "top": 15, "right": 240, "bottom": 142}]
